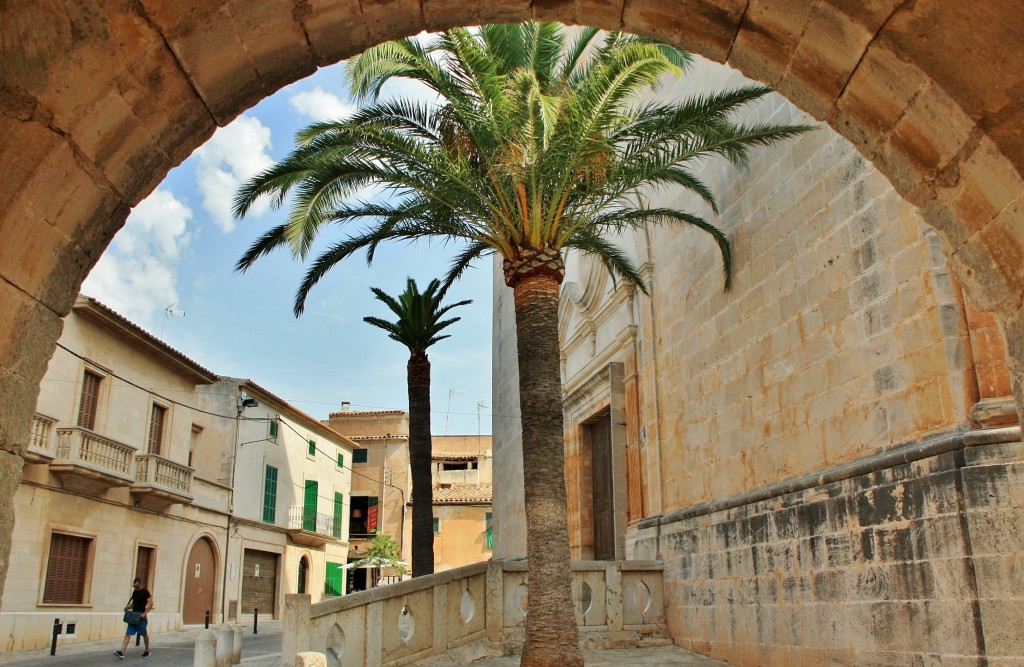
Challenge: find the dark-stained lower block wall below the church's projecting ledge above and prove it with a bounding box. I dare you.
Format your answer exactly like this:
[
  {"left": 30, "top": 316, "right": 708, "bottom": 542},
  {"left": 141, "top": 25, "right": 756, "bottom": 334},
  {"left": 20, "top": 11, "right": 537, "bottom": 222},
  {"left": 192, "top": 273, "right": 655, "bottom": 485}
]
[{"left": 632, "top": 428, "right": 1024, "bottom": 667}]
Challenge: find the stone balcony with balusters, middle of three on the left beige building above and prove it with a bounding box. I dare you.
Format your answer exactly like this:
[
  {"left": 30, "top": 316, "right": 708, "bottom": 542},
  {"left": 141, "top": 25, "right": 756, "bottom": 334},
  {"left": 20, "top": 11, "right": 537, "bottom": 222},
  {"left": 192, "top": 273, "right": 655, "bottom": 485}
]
[{"left": 50, "top": 426, "right": 135, "bottom": 494}]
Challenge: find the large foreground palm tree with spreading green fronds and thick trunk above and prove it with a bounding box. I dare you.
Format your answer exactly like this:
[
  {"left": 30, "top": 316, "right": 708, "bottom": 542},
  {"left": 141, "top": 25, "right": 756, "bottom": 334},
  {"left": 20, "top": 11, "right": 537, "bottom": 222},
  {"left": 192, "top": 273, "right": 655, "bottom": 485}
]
[{"left": 234, "top": 23, "right": 807, "bottom": 667}]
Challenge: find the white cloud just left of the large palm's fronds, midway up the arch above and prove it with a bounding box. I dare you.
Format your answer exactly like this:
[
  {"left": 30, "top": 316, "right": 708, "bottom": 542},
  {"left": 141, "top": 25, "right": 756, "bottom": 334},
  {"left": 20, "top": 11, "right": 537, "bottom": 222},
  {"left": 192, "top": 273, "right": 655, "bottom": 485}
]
[{"left": 196, "top": 116, "right": 273, "bottom": 232}]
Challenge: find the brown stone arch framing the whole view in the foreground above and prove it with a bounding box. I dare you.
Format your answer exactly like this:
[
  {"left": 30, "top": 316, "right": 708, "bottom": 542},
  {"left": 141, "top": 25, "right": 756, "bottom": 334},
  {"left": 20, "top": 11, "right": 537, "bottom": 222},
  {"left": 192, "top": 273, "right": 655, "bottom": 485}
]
[{"left": 0, "top": 0, "right": 1024, "bottom": 594}]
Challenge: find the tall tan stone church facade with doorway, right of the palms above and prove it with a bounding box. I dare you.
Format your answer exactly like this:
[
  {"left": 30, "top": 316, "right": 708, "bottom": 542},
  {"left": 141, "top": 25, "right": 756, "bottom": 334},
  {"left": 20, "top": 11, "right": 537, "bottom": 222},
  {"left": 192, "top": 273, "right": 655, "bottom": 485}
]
[{"left": 494, "top": 57, "right": 1024, "bottom": 666}]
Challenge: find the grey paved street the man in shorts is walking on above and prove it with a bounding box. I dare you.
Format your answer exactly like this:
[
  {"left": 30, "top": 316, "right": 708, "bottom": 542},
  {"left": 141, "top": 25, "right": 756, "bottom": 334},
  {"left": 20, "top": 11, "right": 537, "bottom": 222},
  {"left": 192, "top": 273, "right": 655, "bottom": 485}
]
[{"left": 0, "top": 621, "right": 282, "bottom": 667}]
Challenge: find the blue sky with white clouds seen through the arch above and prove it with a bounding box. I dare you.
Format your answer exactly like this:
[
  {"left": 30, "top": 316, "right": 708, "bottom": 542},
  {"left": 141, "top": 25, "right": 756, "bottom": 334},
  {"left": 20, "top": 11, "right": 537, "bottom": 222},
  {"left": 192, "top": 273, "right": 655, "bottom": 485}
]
[{"left": 82, "top": 59, "right": 492, "bottom": 434}]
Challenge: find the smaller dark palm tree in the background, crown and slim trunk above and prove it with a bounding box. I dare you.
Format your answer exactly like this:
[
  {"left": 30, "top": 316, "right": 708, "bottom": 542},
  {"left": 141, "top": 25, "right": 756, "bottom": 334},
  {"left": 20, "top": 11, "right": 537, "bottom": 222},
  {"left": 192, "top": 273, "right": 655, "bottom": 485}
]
[{"left": 362, "top": 278, "right": 472, "bottom": 578}]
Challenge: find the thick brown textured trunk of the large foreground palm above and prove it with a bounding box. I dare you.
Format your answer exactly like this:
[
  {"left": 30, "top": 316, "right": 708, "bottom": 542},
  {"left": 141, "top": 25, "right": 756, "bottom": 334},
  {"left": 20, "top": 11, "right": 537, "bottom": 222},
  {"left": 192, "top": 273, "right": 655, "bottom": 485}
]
[{"left": 514, "top": 275, "right": 583, "bottom": 667}]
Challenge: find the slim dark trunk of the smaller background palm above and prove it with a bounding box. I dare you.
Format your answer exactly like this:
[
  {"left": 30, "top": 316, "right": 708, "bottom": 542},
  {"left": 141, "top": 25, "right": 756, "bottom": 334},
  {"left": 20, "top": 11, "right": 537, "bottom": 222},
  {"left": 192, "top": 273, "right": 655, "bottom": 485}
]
[{"left": 407, "top": 353, "right": 434, "bottom": 578}]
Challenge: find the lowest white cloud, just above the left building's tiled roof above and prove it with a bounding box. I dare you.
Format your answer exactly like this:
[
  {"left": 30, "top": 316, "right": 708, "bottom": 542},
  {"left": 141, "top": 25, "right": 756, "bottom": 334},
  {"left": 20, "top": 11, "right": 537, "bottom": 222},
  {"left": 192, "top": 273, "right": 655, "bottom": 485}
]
[{"left": 82, "top": 189, "right": 193, "bottom": 327}]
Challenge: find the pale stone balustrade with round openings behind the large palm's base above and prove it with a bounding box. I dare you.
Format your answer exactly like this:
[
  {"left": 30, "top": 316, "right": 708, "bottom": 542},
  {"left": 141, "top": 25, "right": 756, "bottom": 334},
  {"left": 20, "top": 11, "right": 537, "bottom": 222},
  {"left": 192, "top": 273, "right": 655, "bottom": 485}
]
[{"left": 282, "top": 560, "right": 670, "bottom": 667}]
